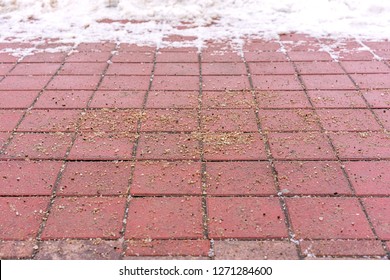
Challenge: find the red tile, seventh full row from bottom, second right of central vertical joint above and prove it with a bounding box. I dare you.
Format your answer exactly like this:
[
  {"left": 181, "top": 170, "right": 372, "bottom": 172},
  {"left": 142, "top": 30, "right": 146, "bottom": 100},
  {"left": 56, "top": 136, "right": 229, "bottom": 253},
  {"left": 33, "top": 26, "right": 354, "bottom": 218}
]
[{"left": 249, "top": 62, "right": 295, "bottom": 75}]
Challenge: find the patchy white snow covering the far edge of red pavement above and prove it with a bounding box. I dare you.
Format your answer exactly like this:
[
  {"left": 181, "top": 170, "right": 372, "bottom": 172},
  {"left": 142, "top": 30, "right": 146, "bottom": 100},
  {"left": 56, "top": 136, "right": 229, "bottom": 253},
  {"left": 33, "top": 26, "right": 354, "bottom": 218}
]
[{"left": 0, "top": 0, "right": 390, "bottom": 50}]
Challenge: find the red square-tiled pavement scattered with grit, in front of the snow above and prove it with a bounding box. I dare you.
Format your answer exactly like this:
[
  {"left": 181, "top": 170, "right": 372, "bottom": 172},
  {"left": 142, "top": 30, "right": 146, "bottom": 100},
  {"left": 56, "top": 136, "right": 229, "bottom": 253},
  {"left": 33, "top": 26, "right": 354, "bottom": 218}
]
[{"left": 0, "top": 34, "right": 390, "bottom": 259}]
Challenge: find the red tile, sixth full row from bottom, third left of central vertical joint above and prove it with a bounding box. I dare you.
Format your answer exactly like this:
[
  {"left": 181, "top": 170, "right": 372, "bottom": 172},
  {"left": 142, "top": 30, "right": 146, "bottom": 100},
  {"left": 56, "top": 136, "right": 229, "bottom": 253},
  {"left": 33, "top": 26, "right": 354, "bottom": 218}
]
[{"left": 47, "top": 75, "right": 101, "bottom": 90}]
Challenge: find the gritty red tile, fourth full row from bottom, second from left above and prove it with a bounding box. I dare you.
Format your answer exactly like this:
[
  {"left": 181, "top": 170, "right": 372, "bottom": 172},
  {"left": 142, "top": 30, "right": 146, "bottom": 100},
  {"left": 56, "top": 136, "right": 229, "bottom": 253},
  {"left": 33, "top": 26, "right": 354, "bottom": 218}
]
[{"left": 17, "top": 110, "right": 81, "bottom": 132}]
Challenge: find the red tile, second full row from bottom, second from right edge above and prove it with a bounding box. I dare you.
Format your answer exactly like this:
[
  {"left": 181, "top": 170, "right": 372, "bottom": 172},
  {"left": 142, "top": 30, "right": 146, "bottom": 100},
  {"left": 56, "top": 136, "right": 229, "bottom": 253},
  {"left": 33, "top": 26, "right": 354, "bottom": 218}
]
[{"left": 275, "top": 161, "right": 352, "bottom": 195}]
